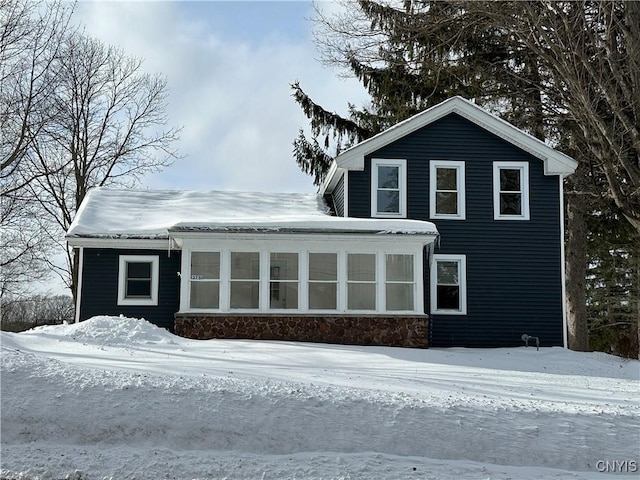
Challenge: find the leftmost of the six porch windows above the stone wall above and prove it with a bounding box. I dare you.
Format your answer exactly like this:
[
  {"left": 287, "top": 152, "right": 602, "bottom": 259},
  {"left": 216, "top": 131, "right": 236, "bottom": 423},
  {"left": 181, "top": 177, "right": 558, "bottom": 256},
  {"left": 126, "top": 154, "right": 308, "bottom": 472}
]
[{"left": 189, "top": 252, "right": 220, "bottom": 309}]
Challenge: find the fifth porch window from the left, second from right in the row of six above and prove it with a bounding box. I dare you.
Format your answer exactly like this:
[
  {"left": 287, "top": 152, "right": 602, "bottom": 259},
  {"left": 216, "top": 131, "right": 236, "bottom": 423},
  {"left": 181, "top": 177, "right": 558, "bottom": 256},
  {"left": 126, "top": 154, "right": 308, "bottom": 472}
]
[{"left": 347, "top": 253, "right": 376, "bottom": 310}]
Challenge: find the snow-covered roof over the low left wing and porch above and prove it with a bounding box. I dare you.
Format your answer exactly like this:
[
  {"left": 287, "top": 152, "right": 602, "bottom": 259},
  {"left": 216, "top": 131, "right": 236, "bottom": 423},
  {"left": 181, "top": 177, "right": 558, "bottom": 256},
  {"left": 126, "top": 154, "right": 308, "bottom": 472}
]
[{"left": 67, "top": 188, "right": 438, "bottom": 240}]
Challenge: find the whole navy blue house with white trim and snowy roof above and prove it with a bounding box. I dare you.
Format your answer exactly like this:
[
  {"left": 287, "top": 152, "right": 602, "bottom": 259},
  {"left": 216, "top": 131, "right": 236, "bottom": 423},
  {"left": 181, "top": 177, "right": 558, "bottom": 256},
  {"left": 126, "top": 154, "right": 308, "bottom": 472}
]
[{"left": 67, "top": 97, "right": 576, "bottom": 347}]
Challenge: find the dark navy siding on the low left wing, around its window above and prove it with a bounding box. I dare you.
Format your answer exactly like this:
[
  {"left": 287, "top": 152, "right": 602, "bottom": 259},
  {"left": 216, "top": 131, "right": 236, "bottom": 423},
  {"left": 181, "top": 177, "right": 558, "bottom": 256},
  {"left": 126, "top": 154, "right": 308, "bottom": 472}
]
[{"left": 80, "top": 248, "right": 181, "bottom": 331}]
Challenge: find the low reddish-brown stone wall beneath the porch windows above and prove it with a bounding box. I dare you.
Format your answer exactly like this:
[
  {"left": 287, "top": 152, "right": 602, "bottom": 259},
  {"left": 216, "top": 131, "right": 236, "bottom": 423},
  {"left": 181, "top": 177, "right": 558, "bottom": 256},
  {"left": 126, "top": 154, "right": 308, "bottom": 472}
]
[{"left": 175, "top": 313, "right": 429, "bottom": 348}]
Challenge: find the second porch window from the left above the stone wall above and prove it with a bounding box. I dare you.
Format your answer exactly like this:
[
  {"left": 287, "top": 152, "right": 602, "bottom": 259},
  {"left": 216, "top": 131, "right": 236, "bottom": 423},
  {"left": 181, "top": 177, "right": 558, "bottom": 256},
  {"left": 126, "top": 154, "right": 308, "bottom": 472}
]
[{"left": 229, "top": 252, "right": 260, "bottom": 309}]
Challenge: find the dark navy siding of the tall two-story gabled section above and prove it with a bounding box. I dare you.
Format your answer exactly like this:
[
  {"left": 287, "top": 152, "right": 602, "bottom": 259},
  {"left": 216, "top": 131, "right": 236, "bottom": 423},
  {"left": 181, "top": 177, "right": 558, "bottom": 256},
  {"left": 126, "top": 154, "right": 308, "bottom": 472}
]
[{"left": 348, "top": 114, "right": 563, "bottom": 347}]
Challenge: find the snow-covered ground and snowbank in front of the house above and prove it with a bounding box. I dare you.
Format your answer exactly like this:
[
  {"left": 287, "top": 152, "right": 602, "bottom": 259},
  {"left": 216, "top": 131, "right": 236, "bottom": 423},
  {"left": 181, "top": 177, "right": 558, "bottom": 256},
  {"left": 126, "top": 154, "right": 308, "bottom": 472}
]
[{"left": 0, "top": 317, "right": 640, "bottom": 480}]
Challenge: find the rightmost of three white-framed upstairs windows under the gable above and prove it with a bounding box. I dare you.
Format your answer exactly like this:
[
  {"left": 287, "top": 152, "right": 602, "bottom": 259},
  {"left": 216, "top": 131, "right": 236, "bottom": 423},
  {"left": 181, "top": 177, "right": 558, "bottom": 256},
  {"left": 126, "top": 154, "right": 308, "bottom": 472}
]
[{"left": 493, "top": 162, "right": 529, "bottom": 220}]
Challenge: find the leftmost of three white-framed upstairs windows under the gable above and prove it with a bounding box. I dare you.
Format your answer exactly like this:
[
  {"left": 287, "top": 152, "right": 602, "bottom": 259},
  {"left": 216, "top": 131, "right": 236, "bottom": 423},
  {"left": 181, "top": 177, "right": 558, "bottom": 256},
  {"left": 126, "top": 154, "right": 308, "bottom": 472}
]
[{"left": 371, "top": 158, "right": 407, "bottom": 217}]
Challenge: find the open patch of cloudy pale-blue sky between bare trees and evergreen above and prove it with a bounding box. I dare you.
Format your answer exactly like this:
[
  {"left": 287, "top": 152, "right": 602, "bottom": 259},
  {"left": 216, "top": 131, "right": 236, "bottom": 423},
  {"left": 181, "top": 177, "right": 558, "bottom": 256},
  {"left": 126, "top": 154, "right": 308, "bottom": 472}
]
[{"left": 75, "top": 1, "right": 366, "bottom": 192}]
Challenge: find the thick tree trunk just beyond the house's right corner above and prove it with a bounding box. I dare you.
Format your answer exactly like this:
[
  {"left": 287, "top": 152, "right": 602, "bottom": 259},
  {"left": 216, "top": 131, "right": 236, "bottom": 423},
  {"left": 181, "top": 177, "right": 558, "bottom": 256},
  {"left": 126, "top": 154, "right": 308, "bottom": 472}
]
[{"left": 566, "top": 184, "right": 589, "bottom": 352}]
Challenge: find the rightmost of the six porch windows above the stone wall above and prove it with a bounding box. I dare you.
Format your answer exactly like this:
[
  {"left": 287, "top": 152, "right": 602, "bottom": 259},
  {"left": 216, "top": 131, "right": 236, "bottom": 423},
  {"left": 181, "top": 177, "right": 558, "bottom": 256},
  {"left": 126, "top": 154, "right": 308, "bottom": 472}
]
[{"left": 385, "top": 254, "right": 416, "bottom": 311}]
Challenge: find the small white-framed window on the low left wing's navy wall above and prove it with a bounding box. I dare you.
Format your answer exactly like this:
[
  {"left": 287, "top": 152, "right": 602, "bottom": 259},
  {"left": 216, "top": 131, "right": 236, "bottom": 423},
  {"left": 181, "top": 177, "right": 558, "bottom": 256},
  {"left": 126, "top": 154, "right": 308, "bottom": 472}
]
[{"left": 118, "top": 255, "right": 160, "bottom": 306}]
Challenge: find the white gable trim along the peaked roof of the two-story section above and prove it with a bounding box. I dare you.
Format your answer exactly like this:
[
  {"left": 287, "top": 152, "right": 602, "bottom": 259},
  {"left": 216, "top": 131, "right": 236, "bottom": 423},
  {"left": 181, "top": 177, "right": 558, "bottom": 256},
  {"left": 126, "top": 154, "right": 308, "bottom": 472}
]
[{"left": 336, "top": 96, "right": 578, "bottom": 175}]
